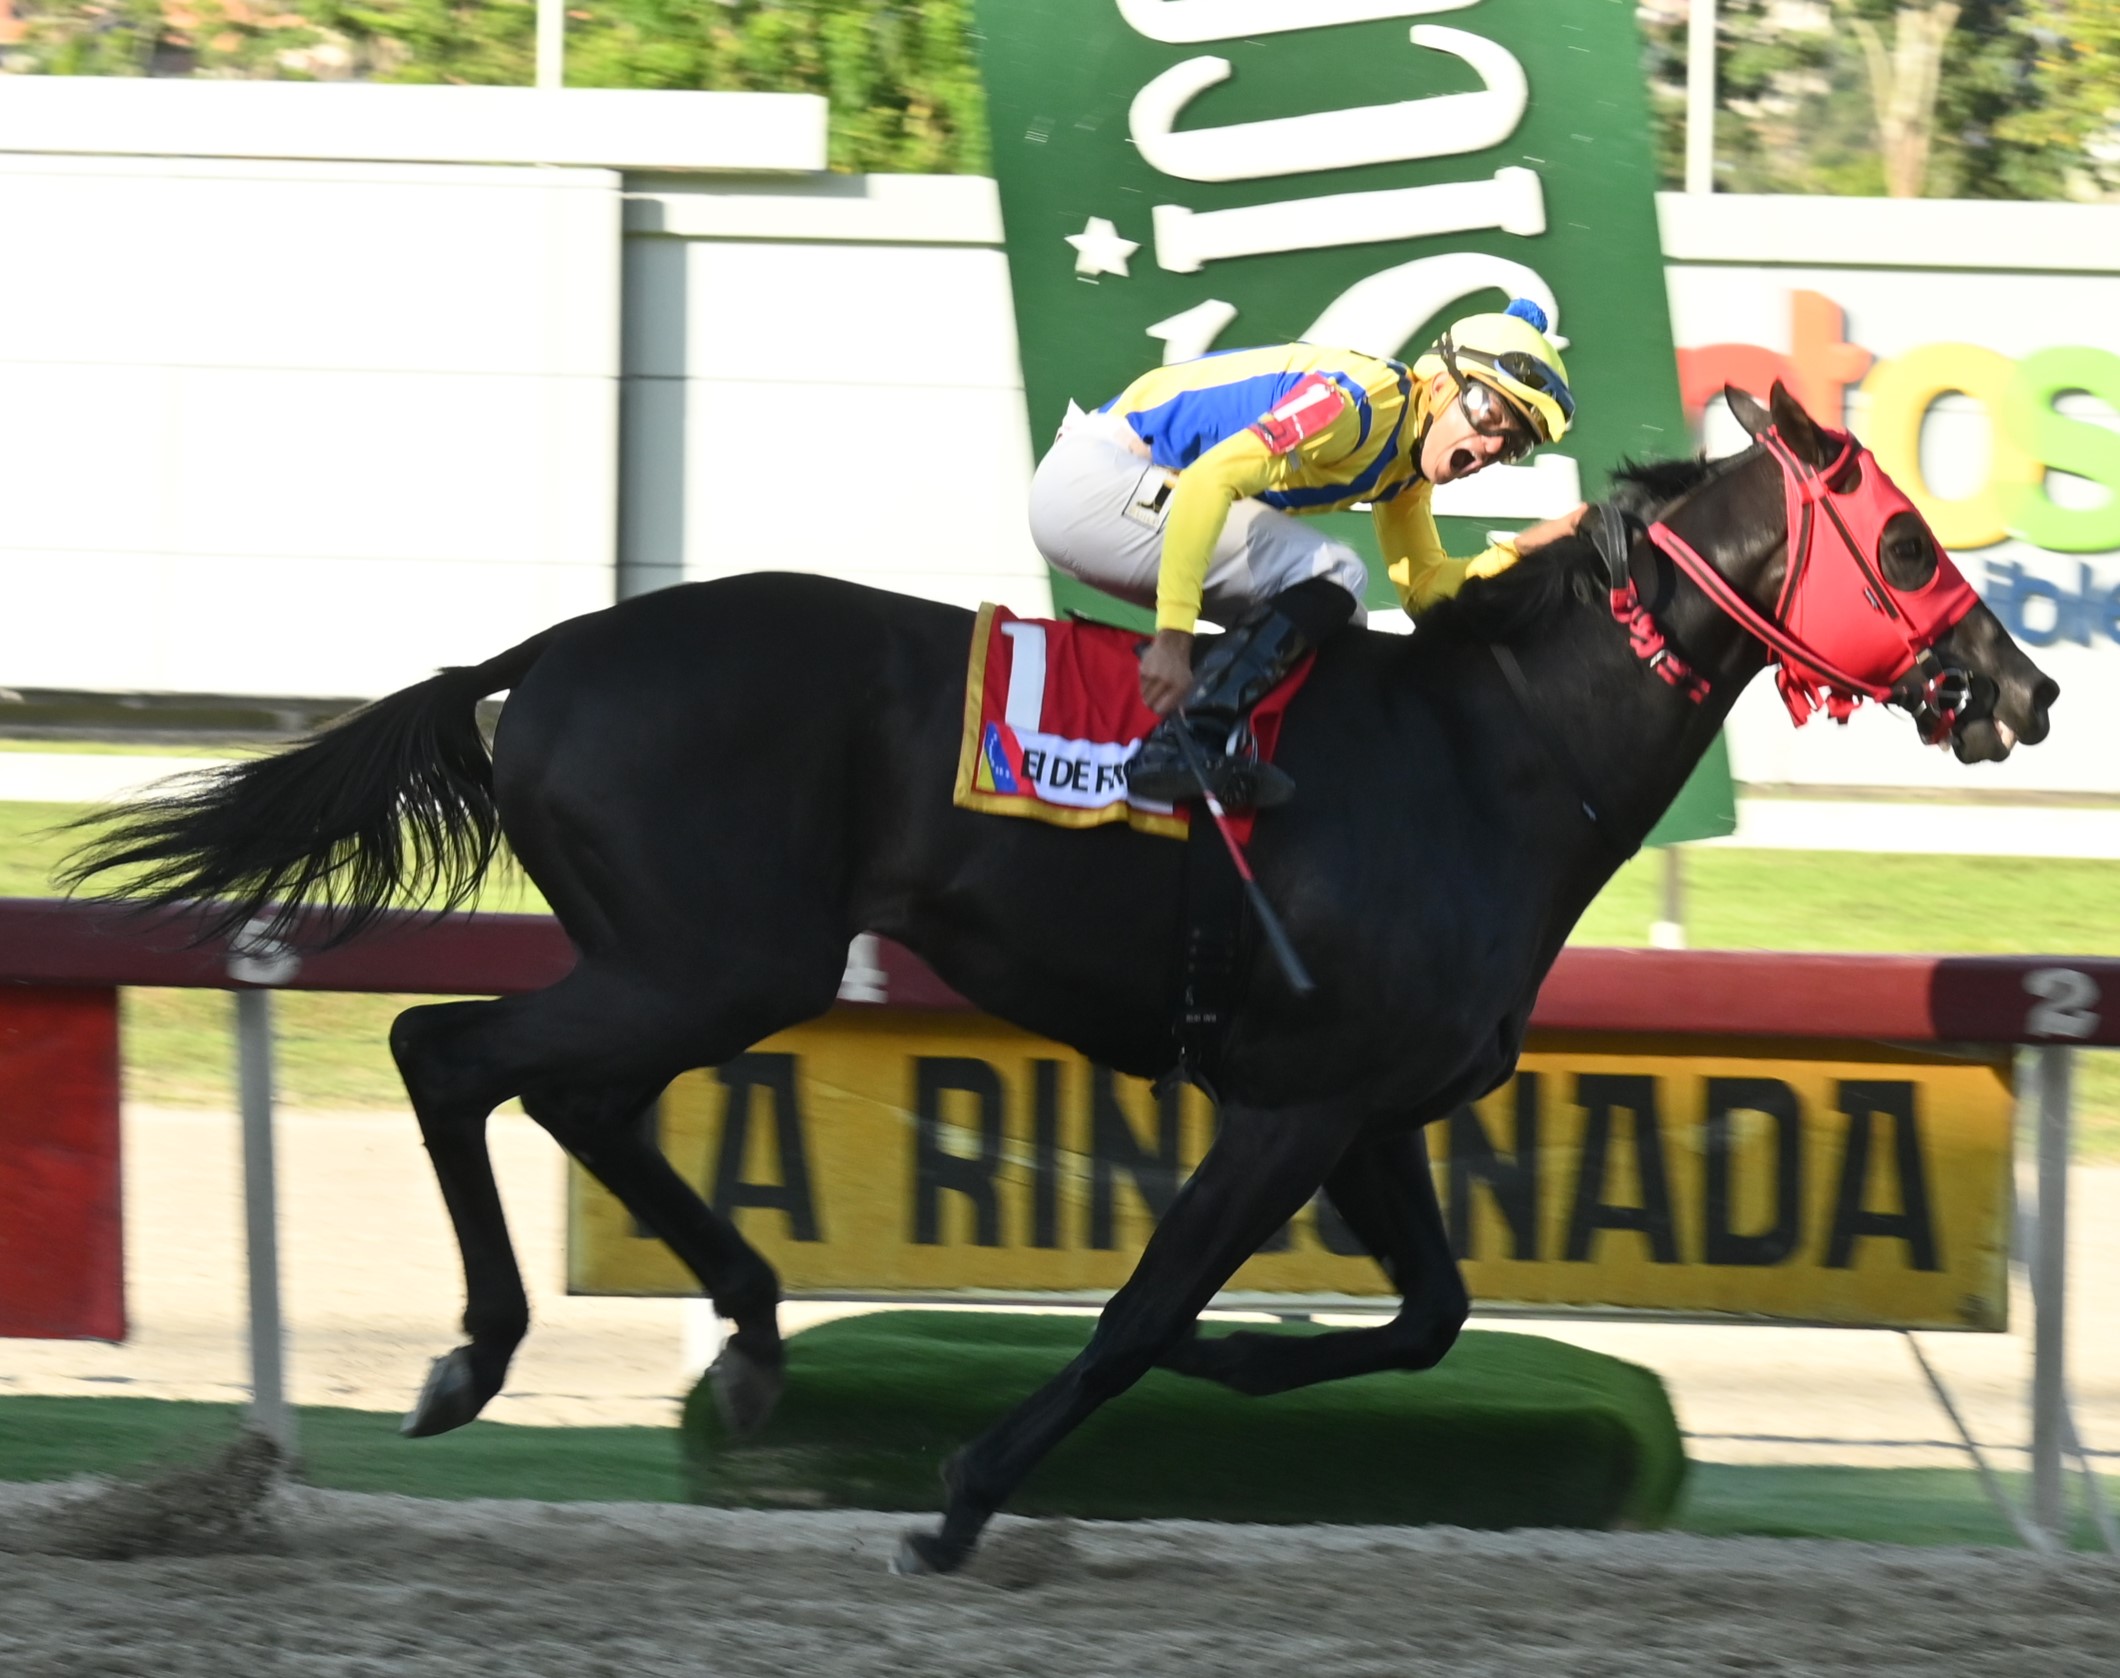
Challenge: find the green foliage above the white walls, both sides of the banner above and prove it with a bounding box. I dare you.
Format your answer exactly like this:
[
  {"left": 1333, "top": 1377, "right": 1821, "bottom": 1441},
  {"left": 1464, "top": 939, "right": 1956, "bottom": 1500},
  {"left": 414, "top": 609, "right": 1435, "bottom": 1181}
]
[{"left": 0, "top": 0, "right": 2120, "bottom": 199}]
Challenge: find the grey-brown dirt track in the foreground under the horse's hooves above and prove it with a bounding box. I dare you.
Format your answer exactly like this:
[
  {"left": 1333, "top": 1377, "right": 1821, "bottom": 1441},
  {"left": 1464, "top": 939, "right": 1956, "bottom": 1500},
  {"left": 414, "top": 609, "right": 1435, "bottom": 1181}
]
[{"left": 0, "top": 1487, "right": 2120, "bottom": 1678}]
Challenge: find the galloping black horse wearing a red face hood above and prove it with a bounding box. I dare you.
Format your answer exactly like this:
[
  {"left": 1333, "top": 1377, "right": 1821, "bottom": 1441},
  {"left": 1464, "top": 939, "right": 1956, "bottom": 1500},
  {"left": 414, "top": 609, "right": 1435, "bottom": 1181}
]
[{"left": 72, "top": 386, "right": 2056, "bottom": 1570}]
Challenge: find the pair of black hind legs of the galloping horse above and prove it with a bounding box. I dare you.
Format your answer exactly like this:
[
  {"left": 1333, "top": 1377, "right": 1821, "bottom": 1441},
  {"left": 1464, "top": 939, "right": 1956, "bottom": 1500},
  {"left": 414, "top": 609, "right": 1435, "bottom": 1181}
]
[{"left": 390, "top": 962, "right": 837, "bottom": 1434}]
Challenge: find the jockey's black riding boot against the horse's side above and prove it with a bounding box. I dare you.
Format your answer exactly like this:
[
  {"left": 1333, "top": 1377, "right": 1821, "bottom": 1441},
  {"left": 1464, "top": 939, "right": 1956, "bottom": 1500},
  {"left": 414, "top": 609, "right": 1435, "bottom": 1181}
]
[{"left": 1126, "top": 606, "right": 1317, "bottom": 809}]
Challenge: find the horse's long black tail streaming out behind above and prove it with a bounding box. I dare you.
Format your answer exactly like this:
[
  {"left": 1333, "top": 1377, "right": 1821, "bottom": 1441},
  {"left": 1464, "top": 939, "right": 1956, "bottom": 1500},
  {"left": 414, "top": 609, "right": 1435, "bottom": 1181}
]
[{"left": 59, "top": 629, "right": 551, "bottom": 947}]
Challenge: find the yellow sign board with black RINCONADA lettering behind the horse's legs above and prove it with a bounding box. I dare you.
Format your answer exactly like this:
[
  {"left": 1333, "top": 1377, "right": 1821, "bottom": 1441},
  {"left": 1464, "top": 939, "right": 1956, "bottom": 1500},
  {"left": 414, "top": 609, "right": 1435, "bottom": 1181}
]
[{"left": 568, "top": 1011, "right": 2012, "bottom": 1331}]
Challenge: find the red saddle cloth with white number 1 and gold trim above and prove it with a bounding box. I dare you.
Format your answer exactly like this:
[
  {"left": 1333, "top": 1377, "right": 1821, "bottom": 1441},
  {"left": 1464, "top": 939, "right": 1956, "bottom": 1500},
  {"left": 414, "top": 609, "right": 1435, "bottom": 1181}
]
[{"left": 956, "top": 606, "right": 1310, "bottom": 839}]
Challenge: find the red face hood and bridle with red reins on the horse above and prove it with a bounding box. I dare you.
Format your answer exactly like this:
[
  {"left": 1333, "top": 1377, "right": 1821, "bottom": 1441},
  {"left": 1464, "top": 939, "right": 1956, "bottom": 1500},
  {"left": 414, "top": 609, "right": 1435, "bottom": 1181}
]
[{"left": 1592, "top": 428, "right": 1980, "bottom": 746}]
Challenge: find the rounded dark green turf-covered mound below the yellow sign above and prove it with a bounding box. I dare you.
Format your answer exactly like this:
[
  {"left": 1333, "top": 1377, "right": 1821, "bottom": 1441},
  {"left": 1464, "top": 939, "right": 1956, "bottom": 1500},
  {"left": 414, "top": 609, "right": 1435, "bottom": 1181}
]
[{"left": 685, "top": 1311, "right": 1685, "bottom": 1528}]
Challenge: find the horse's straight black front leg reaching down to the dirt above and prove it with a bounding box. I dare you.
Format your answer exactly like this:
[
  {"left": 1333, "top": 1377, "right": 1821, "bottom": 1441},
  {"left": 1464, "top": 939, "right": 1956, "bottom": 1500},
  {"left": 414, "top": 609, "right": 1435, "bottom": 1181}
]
[{"left": 895, "top": 1106, "right": 1359, "bottom": 1572}]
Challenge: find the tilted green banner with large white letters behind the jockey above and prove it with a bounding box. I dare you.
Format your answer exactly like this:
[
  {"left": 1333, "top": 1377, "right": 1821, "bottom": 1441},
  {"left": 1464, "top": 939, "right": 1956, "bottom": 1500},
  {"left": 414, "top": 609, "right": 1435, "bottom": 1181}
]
[{"left": 977, "top": 0, "right": 1736, "bottom": 843}]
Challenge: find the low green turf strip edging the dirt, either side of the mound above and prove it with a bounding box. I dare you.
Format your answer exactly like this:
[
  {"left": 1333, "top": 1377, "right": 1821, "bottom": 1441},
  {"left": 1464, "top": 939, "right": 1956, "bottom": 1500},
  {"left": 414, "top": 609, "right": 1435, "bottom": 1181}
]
[{"left": 0, "top": 1396, "right": 2120, "bottom": 1549}]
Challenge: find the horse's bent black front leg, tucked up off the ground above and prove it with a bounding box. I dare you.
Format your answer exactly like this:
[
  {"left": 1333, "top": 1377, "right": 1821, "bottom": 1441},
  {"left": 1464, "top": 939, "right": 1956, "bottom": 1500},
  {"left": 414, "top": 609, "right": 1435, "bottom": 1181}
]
[{"left": 1164, "top": 1129, "right": 1471, "bottom": 1394}]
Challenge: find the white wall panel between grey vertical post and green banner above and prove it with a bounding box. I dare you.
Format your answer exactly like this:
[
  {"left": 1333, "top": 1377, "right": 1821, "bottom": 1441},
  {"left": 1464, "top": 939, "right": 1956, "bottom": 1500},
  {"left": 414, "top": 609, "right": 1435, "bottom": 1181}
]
[{"left": 623, "top": 193, "right": 1052, "bottom": 612}]
